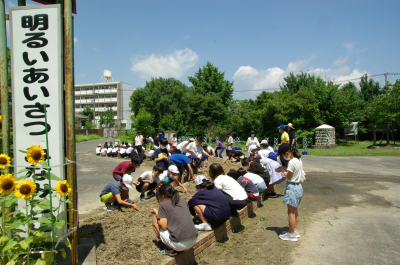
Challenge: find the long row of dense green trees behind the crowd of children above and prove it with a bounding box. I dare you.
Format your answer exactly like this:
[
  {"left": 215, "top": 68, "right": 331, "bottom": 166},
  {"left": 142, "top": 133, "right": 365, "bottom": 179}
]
[{"left": 130, "top": 62, "right": 400, "bottom": 143}]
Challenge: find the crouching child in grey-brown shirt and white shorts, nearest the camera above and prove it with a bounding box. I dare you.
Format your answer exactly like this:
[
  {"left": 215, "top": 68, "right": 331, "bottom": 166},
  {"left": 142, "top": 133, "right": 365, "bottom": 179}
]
[{"left": 150, "top": 183, "right": 198, "bottom": 257}]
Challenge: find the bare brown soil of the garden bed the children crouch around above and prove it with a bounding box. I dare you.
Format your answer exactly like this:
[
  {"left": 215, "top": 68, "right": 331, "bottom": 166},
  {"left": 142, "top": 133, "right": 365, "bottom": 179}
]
[{"left": 79, "top": 158, "right": 245, "bottom": 265}]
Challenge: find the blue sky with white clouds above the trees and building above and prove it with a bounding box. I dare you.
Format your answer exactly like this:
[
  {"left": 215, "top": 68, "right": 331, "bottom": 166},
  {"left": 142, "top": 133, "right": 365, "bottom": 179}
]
[{"left": 5, "top": 0, "right": 400, "bottom": 99}]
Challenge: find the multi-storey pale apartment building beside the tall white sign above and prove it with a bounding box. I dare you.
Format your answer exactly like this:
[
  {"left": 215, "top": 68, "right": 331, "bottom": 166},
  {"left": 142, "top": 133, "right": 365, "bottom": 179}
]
[{"left": 75, "top": 82, "right": 133, "bottom": 129}]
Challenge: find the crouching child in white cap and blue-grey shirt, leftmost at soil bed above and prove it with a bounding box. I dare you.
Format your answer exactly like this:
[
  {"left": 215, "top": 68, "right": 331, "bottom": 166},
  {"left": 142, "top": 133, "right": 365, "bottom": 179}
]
[{"left": 100, "top": 174, "right": 139, "bottom": 212}]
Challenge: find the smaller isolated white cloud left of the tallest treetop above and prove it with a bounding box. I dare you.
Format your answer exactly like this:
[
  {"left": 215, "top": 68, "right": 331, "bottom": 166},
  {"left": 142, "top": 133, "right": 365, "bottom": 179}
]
[{"left": 131, "top": 48, "right": 199, "bottom": 79}]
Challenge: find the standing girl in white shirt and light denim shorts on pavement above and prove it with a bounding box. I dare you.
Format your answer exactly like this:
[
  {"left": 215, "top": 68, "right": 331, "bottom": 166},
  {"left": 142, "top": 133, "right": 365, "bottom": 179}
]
[{"left": 275, "top": 144, "right": 306, "bottom": 242}]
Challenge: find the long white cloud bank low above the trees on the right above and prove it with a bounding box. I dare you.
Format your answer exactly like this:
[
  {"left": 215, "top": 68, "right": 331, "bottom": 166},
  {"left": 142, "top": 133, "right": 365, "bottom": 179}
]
[{"left": 233, "top": 56, "right": 369, "bottom": 97}]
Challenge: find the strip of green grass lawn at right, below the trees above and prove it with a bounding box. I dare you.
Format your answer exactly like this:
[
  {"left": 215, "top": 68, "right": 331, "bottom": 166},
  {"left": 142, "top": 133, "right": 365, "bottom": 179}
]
[{"left": 299, "top": 141, "right": 400, "bottom": 156}]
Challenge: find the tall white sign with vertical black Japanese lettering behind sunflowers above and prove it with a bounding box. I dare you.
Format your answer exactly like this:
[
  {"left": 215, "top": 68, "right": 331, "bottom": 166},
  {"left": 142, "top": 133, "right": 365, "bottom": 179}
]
[{"left": 9, "top": 5, "right": 65, "bottom": 226}]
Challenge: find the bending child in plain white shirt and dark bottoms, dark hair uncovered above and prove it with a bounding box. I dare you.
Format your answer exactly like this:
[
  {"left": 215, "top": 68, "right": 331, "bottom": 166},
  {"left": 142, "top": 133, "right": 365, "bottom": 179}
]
[{"left": 208, "top": 163, "right": 247, "bottom": 217}]
